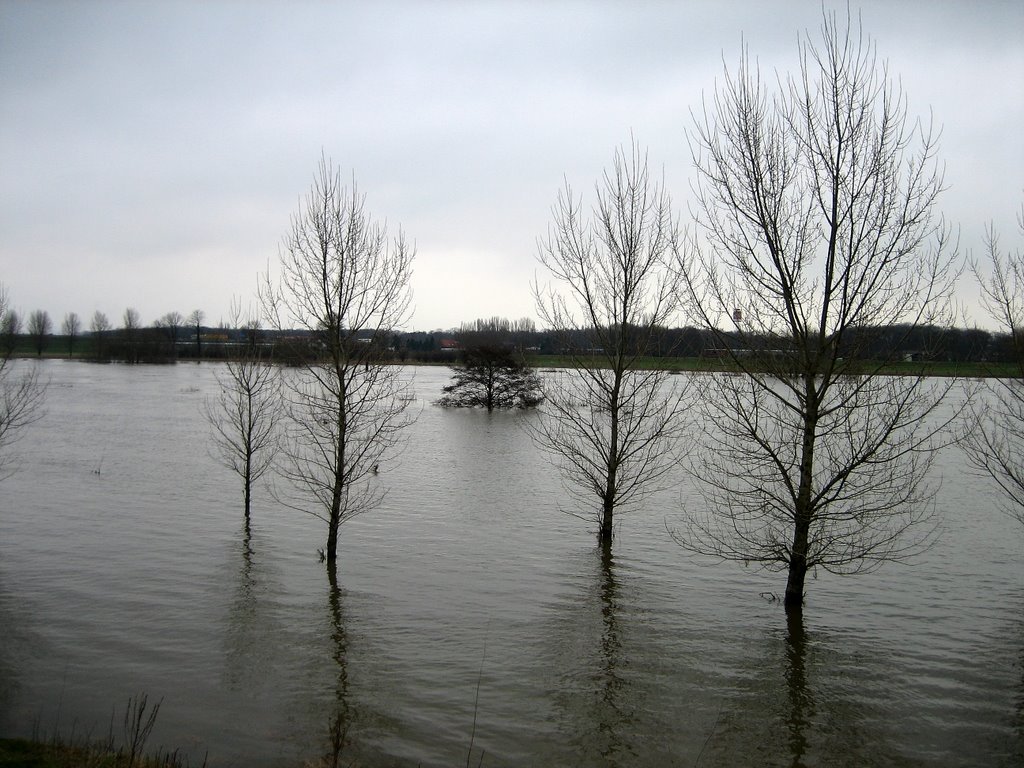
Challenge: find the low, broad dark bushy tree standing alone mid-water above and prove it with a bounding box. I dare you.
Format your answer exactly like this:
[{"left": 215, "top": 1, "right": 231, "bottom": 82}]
[{"left": 437, "top": 345, "right": 544, "bottom": 411}]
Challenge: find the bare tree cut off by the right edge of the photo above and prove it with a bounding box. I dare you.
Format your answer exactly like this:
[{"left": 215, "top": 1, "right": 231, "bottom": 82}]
[{"left": 964, "top": 207, "right": 1024, "bottom": 522}]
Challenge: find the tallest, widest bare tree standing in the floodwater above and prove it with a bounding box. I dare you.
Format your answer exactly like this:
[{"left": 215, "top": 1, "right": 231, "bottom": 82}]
[{"left": 677, "top": 13, "right": 959, "bottom": 609}]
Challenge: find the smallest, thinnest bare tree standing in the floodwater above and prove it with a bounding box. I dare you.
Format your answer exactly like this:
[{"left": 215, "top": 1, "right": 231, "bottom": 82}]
[{"left": 204, "top": 303, "right": 281, "bottom": 529}]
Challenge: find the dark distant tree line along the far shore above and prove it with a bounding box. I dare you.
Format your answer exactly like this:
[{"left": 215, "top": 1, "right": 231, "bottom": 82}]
[{"left": 0, "top": 308, "right": 1017, "bottom": 364}]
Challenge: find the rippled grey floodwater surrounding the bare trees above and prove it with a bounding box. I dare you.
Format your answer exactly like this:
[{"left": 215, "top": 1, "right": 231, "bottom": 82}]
[{"left": 0, "top": 361, "right": 1024, "bottom": 766}]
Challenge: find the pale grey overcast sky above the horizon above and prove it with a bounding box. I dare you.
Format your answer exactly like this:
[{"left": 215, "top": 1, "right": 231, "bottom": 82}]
[{"left": 0, "top": 0, "right": 1024, "bottom": 330}]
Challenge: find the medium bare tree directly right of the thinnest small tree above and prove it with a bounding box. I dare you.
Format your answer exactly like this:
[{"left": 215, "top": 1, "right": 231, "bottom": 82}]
[{"left": 260, "top": 158, "right": 414, "bottom": 567}]
